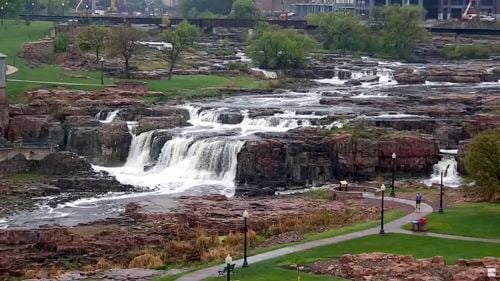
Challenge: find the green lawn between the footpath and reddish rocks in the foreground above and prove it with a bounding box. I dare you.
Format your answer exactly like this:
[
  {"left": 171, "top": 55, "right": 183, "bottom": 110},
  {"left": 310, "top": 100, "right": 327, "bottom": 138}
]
[{"left": 202, "top": 234, "right": 500, "bottom": 281}]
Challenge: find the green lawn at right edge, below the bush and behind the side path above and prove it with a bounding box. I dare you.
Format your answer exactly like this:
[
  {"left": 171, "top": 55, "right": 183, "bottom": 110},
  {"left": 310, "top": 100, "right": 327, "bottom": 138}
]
[{"left": 422, "top": 203, "right": 500, "bottom": 239}]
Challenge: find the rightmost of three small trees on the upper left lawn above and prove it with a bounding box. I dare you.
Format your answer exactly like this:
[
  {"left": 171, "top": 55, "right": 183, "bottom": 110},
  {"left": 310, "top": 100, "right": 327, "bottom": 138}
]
[{"left": 161, "top": 20, "right": 198, "bottom": 80}]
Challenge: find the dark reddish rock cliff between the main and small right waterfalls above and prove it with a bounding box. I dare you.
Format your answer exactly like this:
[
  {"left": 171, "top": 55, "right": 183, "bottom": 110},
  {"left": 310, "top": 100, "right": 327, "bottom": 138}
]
[{"left": 236, "top": 129, "right": 439, "bottom": 192}]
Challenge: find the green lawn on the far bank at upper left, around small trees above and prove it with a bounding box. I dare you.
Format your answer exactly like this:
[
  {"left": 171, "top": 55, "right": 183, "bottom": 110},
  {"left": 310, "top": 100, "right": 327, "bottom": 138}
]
[{"left": 0, "top": 20, "right": 272, "bottom": 103}]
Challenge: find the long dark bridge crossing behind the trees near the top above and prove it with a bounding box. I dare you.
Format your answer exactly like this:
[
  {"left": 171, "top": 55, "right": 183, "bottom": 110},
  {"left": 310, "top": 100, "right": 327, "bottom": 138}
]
[{"left": 20, "top": 14, "right": 500, "bottom": 35}]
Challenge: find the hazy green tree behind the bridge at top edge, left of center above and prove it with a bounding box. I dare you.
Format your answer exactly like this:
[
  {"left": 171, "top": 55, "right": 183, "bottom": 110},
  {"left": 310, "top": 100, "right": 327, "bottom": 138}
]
[{"left": 179, "top": 0, "right": 233, "bottom": 18}]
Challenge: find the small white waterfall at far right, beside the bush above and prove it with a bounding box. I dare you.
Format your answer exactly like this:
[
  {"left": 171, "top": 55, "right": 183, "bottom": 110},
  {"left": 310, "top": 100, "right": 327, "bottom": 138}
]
[{"left": 424, "top": 155, "right": 462, "bottom": 187}]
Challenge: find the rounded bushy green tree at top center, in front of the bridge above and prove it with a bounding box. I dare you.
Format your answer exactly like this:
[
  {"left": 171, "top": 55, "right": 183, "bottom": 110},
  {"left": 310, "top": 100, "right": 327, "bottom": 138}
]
[{"left": 248, "top": 24, "right": 317, "bottom": 69}]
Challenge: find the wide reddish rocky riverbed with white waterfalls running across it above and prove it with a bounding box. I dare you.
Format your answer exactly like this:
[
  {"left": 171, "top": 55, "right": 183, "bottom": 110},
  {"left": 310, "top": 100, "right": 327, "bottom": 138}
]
[{"left": 0, "top": 53, "right": 500, "bottom": 275}]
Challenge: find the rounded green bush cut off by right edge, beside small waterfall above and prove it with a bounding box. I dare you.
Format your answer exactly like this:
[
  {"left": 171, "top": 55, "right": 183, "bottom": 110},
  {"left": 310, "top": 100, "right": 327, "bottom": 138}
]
[{"left": 465, "top": 129, "right": 500, "bottom": 200}]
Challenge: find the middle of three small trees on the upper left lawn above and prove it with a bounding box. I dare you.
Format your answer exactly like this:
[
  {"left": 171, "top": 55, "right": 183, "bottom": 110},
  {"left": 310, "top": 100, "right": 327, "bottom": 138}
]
[{"left": 107, "top": 26, "right": 143, "bottom": 78}]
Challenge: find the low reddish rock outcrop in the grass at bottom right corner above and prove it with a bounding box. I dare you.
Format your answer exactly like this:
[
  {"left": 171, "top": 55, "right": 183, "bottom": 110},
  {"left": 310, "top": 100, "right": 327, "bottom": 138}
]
[{"left": 310, "top": 253, "right": 500, "bottom": 281}]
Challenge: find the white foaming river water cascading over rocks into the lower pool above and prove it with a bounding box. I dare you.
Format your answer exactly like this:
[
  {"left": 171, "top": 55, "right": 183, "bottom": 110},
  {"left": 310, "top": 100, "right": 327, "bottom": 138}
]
[{"left": 0, "top": 58, "right": 496, "bottom": 228}]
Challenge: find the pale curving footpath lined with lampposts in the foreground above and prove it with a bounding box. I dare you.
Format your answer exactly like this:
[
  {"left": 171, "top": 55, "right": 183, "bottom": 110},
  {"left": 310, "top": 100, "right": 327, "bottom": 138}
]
[{"left": 177, "top": 193, "right": 434, "bottom": 281}]
